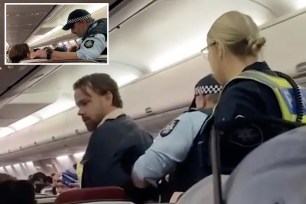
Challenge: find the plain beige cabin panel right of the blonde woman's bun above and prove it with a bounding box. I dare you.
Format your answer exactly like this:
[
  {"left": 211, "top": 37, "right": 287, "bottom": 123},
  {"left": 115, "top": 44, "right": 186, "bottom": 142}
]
[{"left": 262, "top": 10, "right": 306, "bottom": 75}]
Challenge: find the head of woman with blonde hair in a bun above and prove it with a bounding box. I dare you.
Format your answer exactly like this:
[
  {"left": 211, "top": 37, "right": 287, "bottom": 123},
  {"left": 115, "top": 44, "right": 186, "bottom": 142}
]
[{"left": 202, "top": 11, "right": 266, "bottom": 85}]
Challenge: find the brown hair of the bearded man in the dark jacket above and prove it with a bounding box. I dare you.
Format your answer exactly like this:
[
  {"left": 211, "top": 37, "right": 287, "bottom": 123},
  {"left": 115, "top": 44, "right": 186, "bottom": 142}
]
[{"left": 73, "top": 73, "right": 123, "bottom": 108}]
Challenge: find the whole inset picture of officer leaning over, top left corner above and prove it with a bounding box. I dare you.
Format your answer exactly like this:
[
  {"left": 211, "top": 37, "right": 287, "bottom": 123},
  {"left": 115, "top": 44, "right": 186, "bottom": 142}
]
[{"left": 4, "top": 3, "right": 109, "bottom": 65}]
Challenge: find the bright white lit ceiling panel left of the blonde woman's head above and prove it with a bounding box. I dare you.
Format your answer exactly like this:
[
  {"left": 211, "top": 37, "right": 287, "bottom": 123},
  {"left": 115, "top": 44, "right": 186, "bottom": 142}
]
[{"left": 110, "top": 0, "right": 275, "bottom": 69}]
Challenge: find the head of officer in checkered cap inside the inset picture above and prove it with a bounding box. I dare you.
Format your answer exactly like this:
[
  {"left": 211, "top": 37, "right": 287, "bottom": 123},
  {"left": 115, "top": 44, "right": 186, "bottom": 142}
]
[{"left": 63, "top": 9, "right": 94, "bottom": 38}]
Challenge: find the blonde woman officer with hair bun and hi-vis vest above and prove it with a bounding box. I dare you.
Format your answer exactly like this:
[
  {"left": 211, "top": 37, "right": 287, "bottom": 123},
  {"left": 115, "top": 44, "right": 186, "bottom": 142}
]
[{"left": 202, "top": 11, "right": 306, "bottom": 173}]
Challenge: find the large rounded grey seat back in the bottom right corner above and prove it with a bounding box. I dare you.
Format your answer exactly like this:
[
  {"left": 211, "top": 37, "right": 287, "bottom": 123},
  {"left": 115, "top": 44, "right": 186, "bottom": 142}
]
[{"left": 223, "top": 127, "right": 306, "bottom": 204}]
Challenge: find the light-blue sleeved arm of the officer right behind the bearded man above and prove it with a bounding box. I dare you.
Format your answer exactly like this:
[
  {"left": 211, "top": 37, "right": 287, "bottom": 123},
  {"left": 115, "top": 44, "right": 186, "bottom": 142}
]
[{"left": 132, "top": 111, "right": 207, "bottom": 188}]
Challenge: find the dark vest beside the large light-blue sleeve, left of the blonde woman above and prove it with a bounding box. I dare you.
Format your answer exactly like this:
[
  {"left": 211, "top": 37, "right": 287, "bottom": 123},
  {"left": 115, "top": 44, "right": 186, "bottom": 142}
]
[{"left": 164, "top": 109, "right": 212, "bottom": 198}]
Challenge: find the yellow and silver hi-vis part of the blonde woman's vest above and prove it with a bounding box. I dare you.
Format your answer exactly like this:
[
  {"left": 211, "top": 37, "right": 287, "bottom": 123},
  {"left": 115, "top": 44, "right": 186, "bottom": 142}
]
[{"left": 228, "top": 70, "right": 306, "bottom": 123}]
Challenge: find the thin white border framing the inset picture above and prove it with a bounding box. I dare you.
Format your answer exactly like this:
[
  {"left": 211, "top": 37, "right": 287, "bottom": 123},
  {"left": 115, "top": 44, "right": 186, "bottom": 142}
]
[{"left": 4, "top": 3, "right": 110, "bottom": 66}]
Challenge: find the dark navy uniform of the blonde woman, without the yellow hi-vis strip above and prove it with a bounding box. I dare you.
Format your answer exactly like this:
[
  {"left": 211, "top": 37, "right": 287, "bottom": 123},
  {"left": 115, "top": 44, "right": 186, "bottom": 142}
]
[{"left": 213, "top": 62, "right": 282, "bottom": 173}]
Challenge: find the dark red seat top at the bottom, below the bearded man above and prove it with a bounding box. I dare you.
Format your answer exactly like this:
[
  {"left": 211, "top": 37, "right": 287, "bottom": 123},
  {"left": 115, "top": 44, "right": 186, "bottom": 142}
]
[{"left": 55, "top": 186, "right": 129, "bottom": 204}]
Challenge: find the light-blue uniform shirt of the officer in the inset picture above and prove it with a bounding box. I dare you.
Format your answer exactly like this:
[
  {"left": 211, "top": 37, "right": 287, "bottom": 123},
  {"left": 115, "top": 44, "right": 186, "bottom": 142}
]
[{"left": 76, "top": 21, "right": 106, "bottom": 60}]
